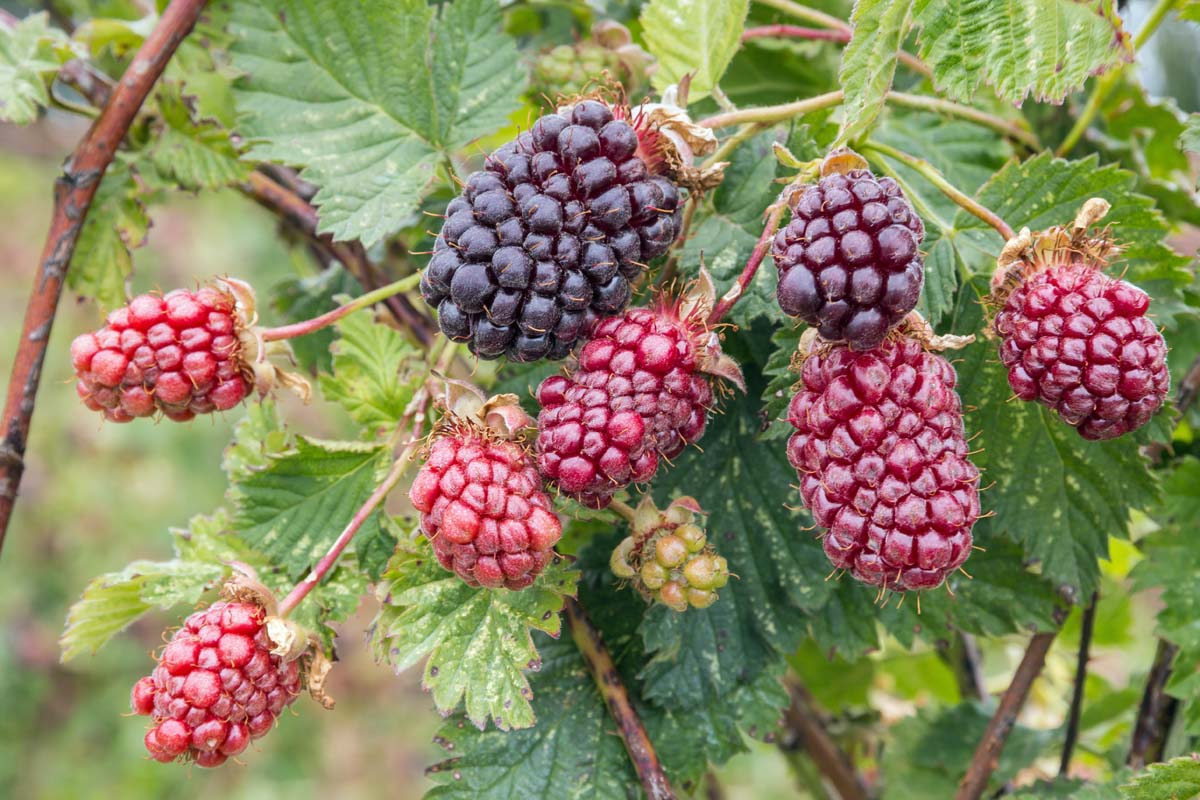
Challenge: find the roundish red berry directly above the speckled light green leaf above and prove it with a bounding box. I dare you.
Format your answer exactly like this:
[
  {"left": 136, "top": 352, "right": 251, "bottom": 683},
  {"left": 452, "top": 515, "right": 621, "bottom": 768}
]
[{"left": 409, "top": 422, "right": 563, "bottom": 589}]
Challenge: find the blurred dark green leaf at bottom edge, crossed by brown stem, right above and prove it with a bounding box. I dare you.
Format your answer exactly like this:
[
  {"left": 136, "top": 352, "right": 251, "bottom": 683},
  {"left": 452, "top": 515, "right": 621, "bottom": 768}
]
[{"left": 880, "top": 703, "right": 1050, "bottom": 800}]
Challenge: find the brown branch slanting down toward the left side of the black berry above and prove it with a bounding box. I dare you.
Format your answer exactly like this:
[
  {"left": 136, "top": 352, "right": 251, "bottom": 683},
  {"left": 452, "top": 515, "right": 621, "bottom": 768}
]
[{"left": 241, "top": 172, "right": 434, "bottom": 345}]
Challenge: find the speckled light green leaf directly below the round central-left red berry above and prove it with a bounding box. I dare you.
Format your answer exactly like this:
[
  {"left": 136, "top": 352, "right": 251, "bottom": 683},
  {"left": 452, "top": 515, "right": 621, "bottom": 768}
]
[{"left": 372, "top": 540, "right": 578, "bottom": 730}]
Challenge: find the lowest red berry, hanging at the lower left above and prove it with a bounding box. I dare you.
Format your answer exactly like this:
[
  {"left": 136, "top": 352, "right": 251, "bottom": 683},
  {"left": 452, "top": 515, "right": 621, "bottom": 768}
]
[{"left": 131, "top": 602, "right": 300, "bottom": 766}]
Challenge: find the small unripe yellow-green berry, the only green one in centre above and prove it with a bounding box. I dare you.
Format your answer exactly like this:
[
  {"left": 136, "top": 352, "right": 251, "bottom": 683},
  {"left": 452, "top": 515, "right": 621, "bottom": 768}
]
[{"left": 610, "top": 495, "right": 730, "bottom": 612}]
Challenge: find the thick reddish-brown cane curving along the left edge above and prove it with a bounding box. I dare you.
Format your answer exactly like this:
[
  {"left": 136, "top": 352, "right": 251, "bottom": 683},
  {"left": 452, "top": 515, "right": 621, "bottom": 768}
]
[{"left": 0, "top": 0, "right": 204, "bottom": 547}]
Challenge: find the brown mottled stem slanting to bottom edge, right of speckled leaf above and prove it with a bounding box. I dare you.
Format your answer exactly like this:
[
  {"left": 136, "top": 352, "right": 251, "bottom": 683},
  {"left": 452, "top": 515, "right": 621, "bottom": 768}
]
[{"left": 563, "top": 597, "right": 676, "bottom": 800}]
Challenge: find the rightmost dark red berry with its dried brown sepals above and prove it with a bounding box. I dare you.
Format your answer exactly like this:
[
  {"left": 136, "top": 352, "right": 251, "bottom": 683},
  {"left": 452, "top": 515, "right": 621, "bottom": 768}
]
[{"left": 989, "top": 198, "right": 1170, "bottom": 440}]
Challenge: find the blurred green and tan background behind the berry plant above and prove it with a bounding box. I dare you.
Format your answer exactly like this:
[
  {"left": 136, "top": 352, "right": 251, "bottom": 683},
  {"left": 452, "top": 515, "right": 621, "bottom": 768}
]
[{"left": 0, "top": 4, "right": 1200, "bottom": 800}]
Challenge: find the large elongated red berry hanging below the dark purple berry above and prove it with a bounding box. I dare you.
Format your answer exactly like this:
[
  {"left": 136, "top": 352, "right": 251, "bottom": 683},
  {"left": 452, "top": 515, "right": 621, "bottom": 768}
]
[{"left": 787, "top": 337, "right": 979, "bottom": 590}]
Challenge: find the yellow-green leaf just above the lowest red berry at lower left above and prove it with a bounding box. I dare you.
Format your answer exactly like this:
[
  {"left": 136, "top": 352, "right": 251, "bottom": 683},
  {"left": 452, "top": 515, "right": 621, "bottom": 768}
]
[{"left": 59, "top": 559, "right": 226, "bottom": 661}]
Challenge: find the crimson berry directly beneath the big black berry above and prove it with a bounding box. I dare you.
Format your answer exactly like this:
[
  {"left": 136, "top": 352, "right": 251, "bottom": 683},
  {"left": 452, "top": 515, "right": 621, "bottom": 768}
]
[{"left": 538, "top": 301, "right": 734, "bottom": 509}]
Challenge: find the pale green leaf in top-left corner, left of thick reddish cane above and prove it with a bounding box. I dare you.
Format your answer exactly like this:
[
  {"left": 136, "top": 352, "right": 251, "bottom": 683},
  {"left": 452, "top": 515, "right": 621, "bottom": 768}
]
[{"left": 0, "top": 12, "right": 74, "bottom": 125}]
